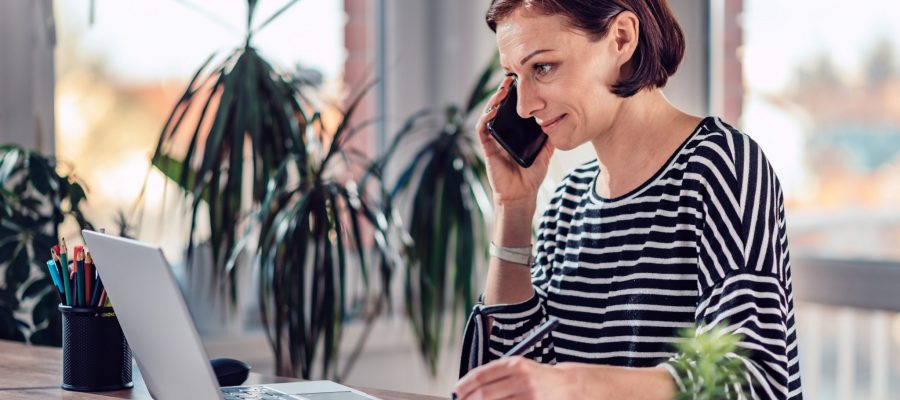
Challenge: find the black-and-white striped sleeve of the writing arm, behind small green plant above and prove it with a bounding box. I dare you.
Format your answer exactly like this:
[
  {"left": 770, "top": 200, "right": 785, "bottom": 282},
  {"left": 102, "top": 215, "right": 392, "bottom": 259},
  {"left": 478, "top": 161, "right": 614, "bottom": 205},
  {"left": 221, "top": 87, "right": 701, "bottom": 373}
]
[{"left": 663, "top": 130, "right": 802, "bottom": 399}]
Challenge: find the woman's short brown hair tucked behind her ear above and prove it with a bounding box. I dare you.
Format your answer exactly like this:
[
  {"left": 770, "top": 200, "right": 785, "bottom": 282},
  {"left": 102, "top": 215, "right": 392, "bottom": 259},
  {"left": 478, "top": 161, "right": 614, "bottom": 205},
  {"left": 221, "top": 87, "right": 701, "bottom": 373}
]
[{"left": 485, "top": 0, "right": 684, "bottom": 97}]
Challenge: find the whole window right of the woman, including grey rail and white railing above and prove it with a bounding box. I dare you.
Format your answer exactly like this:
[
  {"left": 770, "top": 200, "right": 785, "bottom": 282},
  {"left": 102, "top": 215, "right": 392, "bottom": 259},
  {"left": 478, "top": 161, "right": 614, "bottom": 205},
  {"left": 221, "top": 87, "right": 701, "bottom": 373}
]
[{"left": 740, "top": 0, "right": 900, "bottom": 399}]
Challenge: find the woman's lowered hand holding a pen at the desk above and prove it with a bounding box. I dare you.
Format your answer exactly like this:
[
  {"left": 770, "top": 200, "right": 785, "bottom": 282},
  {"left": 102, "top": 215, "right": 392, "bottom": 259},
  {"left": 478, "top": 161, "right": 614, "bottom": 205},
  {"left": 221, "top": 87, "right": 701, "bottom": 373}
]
[{"left": 454, "top": 356, "right": 574, "bottom": 400}]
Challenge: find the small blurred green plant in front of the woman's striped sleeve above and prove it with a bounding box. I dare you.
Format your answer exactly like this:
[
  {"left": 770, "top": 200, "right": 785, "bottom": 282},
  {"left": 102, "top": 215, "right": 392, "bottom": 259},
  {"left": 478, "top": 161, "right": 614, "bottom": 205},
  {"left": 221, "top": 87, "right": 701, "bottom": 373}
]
[{"left": 671, "top": 326, "right": 746, "bottom": 400}]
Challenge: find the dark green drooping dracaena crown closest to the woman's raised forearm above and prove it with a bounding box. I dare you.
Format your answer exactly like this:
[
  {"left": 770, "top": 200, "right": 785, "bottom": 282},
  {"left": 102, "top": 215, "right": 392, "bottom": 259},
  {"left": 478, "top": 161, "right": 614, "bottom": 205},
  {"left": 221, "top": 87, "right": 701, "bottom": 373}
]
[{"left": 377, "top": 55, "right": 499, "bottom": 374}]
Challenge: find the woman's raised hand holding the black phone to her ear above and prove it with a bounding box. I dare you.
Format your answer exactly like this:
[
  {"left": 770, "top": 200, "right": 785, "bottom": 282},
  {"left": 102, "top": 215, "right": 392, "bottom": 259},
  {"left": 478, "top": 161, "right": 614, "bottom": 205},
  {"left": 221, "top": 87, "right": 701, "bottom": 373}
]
[{"left": 475, "top": 77, "right": 553, "bottom": 208}]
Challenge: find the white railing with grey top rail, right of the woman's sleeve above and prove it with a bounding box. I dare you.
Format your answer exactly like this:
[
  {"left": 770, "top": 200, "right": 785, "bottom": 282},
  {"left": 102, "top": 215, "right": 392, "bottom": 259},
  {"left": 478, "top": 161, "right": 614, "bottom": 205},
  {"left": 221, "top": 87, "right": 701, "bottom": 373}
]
[{"left": 792, "top": 259, "right": 900, "bottom": 400}]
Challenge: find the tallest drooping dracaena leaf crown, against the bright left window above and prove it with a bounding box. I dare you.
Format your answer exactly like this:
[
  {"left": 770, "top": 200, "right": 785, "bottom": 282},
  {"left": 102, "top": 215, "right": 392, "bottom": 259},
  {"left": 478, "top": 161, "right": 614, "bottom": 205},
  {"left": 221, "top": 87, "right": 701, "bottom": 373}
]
[{"left": 152, "top": 0, "right": 312, "bottom": 303}]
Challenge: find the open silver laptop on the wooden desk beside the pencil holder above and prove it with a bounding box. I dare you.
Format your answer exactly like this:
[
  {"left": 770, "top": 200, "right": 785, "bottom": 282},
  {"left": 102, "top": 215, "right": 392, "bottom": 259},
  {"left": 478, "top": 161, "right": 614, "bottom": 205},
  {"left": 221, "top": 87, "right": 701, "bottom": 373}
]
[{"left": 82, "top": 230, "right": 376, "bottom": 400}]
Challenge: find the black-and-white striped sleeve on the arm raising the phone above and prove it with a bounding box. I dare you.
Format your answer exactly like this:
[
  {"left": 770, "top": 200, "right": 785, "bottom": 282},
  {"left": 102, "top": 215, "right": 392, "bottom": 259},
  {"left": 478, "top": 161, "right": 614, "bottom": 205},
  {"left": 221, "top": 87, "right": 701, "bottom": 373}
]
[{"left": 459, "top": 182, "right": 565, "bottom": 377}]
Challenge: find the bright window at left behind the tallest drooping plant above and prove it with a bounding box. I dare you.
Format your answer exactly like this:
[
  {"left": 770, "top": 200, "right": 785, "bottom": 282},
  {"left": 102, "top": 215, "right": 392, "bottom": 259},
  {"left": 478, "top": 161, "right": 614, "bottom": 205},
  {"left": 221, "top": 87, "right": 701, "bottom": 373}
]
[{"left": 55, "top": 0, "right": 345, "bottom": 263}]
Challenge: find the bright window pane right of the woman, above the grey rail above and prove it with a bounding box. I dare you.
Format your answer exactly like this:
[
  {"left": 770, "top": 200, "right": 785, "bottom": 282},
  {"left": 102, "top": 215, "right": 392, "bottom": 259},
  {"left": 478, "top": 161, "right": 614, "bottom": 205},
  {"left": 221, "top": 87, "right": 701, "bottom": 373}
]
[{"left": 738, "top": 0, "right": 900, "bottom": 260}]
